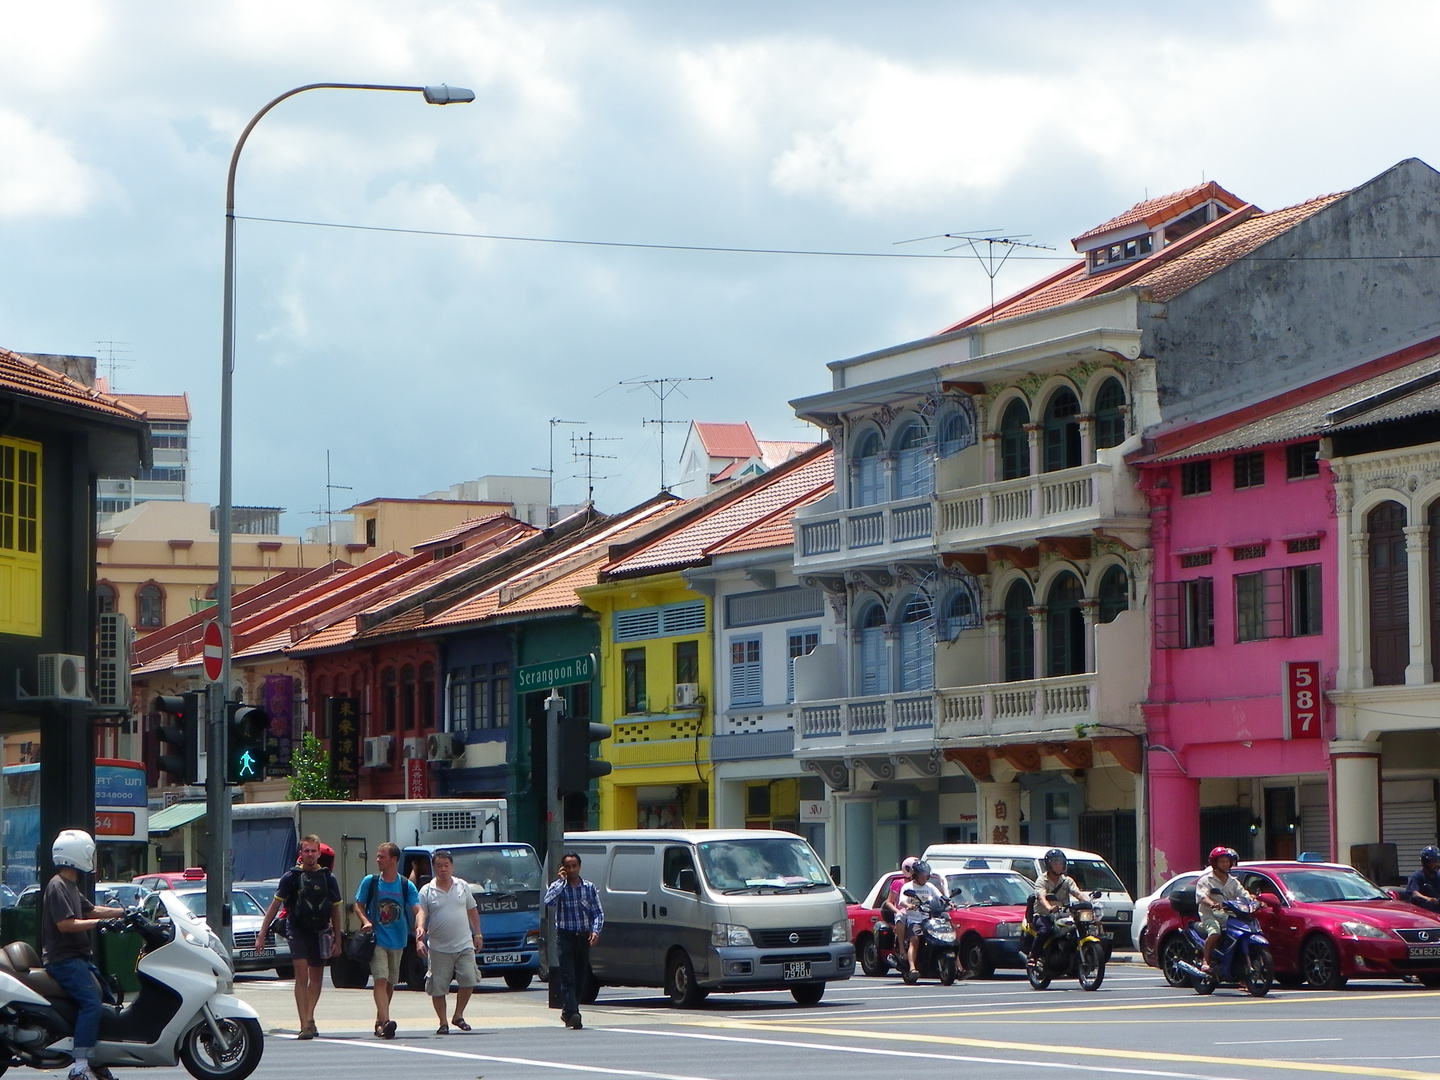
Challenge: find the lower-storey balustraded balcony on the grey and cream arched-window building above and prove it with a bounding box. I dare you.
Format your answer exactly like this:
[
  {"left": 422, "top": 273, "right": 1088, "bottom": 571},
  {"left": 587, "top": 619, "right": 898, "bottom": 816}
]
[{"left": 796, "top": 672, "right": 1100, "bottom": 757}]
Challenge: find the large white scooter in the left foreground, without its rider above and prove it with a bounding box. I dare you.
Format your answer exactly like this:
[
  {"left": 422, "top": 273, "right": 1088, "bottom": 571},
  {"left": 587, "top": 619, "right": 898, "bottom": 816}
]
[{"left": 0, "top": 891, "right": 265, "bottom": 1080}]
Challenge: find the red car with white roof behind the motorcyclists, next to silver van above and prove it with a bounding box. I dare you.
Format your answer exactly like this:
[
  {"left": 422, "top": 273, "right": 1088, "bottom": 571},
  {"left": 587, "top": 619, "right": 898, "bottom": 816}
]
[{"left": 847, "top": 867, "right": 1035, "bottom": 979}]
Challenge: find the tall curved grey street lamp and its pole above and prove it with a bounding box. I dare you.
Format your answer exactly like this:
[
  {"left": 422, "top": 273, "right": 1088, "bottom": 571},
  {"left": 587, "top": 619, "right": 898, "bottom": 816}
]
[{"left": 204, "top": 82, "right": 475, "bottom": 948}]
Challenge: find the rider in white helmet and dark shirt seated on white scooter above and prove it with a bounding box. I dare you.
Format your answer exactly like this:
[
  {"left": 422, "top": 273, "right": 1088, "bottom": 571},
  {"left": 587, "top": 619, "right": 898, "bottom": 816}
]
[{"left": 40, "top": 829, "right": 125, "bottom": 1080}]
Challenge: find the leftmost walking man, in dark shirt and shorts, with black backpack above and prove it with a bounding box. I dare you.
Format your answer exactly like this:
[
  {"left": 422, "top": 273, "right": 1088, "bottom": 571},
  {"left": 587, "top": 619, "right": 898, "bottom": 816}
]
[{"left": 255, "top": 835, "right": 341, "bottom": 1038}]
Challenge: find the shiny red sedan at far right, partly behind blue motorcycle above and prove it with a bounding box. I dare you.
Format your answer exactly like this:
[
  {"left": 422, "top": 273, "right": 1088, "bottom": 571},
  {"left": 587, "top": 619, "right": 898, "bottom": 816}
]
[{"left": 1140, "top": 863, "right": 1440, "bottom": 989}]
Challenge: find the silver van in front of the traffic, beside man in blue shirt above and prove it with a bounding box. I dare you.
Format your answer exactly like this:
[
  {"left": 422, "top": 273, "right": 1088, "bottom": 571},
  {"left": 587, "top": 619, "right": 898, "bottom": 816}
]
[{"left": 564, "top": 829, "right": 855, "bottom": 1008}]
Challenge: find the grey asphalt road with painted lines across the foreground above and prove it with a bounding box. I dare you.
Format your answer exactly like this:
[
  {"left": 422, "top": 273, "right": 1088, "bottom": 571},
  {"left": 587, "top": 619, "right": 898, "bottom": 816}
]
[{"left": 143, "top": 963, "right": 1440, "bottom": 1080}]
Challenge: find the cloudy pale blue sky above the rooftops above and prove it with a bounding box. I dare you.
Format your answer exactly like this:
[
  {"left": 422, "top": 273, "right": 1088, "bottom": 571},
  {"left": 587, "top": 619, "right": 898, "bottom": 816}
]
[{"left": 0, "top": 0, "right": 1440, "bottom": 533}]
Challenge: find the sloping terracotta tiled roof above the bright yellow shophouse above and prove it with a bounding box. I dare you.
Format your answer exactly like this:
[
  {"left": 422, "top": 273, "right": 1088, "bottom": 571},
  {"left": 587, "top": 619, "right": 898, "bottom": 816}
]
[{"left": 605, "top": 444, "right": 835, "bottom": 577}]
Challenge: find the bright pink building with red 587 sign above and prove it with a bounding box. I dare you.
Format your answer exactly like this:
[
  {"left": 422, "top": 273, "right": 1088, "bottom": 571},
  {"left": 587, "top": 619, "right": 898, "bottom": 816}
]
[{"left": 1132, "top": 342, "right": 1440, "bottom": 883}]
